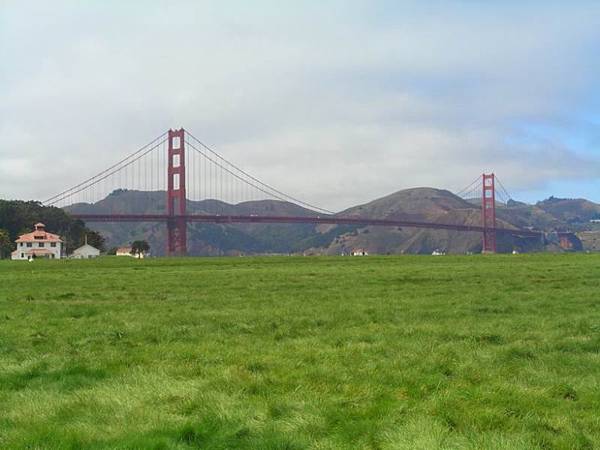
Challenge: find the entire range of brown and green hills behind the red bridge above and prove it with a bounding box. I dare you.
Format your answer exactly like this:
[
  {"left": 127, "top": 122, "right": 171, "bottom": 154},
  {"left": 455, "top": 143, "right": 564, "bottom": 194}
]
[{"left": 68, "top": 188, "right": 600, "bottom": 255}]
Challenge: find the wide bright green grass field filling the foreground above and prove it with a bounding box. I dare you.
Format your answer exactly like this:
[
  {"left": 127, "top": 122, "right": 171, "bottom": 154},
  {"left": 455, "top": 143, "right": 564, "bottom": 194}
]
[{"left": 0, "top": 254, "right": 600, "bottom": 449}]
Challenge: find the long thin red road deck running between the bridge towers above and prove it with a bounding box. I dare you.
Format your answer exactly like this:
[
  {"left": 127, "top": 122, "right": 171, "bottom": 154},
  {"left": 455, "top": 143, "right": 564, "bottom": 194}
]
[{"left": 72, "top": 214, "right": 543, "bottom": 238}]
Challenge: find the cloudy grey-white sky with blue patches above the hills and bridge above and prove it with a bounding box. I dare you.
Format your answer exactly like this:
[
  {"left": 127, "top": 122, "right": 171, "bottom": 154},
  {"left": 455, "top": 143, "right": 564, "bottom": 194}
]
[{"left": 0, "top": 0, "right": 600, "bottom": 210}]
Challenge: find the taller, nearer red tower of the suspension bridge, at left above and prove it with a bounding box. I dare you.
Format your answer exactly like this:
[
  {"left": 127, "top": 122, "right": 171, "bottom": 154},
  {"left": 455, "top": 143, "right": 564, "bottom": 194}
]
[{"left": 167, "top": 128, "right": 187, "bottom": 256}]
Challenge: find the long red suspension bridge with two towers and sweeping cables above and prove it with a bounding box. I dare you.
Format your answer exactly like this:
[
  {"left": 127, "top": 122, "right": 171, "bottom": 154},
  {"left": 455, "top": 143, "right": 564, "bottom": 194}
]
[{"left": 43, "top": 128, "right": 544, "bottom": 256}]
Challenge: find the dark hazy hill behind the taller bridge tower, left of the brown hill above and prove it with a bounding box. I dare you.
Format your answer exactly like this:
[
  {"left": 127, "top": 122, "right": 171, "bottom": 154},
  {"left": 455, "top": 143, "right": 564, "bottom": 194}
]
[{"left": 68, "top": 190, "right": 319, "bottom": 256}]
